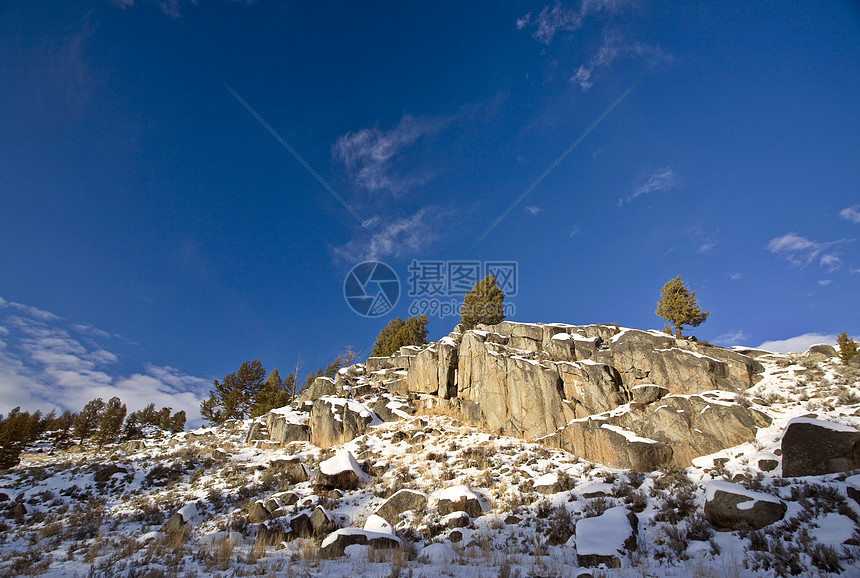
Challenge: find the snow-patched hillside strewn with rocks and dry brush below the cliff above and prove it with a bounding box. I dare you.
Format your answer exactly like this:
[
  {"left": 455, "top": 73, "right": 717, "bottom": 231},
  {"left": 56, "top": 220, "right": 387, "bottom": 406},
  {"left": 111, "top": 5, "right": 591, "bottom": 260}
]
[{"left": 0, "top": 330, "right": 860, "bottom": 578}]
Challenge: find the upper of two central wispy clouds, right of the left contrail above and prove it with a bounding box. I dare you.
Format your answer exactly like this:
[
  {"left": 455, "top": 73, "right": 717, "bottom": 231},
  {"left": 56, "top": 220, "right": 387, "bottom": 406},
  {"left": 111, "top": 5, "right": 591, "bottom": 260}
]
[{"left": 332, "top": 114, "right": 451, "bottom": 193}]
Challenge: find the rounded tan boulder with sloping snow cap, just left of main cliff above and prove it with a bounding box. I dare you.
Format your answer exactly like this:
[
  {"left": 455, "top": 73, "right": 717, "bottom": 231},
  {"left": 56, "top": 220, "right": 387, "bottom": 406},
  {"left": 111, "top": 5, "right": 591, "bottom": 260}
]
[{"left": 308, "top": 397, "right": 379, "bottom": 448}]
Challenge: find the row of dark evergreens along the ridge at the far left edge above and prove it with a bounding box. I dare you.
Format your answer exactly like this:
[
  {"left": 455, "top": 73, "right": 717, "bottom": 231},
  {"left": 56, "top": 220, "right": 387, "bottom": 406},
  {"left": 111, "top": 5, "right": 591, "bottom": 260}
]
[{"left": 0, "top": 397, "right": 186, "bottom": 469}]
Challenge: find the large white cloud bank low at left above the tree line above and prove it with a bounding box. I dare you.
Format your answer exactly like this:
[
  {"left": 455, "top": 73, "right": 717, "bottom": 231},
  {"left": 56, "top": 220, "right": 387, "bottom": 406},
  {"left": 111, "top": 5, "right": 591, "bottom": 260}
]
[{"left": 0, "top": 298, "right": 210, "bottom": 426}]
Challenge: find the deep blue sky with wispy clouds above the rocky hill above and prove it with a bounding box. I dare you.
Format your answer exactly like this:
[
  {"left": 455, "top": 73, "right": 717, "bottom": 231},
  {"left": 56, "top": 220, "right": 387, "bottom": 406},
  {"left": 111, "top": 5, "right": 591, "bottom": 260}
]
[{"left": 0, "top": 0, "right": 860, "bottom": 424}]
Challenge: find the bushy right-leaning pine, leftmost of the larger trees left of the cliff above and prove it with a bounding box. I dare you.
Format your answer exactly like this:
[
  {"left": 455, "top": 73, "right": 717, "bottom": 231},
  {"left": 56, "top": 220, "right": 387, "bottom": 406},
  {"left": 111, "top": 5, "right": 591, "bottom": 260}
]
[{"left": 200, "top": 359, "right": 266, "bottom": 425}]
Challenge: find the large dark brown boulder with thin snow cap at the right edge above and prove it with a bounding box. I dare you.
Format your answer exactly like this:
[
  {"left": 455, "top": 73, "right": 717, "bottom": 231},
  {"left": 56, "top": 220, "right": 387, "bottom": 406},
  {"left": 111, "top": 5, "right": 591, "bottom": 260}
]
[{"left": 782, "top": 417, "right": 860, "bottom": 478}]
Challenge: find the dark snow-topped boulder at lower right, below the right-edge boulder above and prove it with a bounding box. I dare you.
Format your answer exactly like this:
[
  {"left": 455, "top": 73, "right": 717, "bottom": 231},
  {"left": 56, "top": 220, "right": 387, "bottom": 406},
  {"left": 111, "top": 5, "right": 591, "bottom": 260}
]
[{"left": 705, "top": 481, "right": 786, "bottom": 532}]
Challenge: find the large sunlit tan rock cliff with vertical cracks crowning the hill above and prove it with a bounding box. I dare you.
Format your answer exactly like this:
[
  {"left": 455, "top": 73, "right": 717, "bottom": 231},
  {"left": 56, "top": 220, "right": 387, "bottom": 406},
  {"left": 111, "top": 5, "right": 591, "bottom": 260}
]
[{"left": 255, "top": 321, "right": 770, "bottom": 470}]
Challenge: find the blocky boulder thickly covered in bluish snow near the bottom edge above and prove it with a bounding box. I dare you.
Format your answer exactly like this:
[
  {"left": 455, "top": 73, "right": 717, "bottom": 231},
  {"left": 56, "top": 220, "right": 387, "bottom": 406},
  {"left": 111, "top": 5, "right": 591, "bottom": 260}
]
[{"left": 576, "top": 506, "right": 639, "bottom": 568}]
